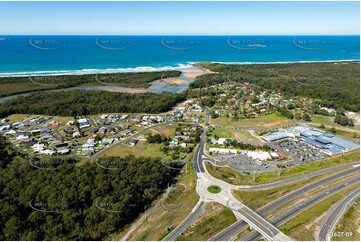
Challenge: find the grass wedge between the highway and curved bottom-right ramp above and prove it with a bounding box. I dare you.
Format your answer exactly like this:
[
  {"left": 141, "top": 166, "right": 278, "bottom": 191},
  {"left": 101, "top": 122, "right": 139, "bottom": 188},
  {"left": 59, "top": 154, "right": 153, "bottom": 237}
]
[{"left": 280, "top": 184, "right": 359, "bottom": 241}]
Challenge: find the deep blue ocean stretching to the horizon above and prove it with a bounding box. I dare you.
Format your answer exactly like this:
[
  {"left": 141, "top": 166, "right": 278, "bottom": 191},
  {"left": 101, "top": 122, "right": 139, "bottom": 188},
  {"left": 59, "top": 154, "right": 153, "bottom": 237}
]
[{"left": 0, "top": 36, "right": 360, "bottom": 76}]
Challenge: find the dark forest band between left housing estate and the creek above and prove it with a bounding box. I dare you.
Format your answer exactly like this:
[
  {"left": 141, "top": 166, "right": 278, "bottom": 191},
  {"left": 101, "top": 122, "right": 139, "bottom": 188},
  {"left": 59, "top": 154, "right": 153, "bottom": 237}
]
[{"left": 0, "top": 90, "right": 185, "bottom": 117}]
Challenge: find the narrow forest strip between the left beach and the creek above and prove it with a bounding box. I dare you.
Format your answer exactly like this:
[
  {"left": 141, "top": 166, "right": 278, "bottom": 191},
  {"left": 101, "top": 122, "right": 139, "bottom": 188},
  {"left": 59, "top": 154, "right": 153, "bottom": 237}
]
[{"left": 0, "top": 71, "right": 181, "bottom": 97}]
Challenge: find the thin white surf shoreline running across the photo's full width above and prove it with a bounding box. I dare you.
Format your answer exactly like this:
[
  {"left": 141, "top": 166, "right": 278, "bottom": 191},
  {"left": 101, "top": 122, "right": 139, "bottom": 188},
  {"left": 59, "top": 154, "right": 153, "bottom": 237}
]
[{"left": 0, "top": 59, "right": 360, "bottom": 78}]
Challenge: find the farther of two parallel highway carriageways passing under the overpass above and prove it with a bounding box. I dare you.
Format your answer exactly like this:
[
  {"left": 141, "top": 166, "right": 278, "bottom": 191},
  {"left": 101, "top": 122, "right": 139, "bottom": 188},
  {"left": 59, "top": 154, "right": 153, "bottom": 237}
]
[{"left": 210, "top": 167, "right": 359, "bottom": 241}]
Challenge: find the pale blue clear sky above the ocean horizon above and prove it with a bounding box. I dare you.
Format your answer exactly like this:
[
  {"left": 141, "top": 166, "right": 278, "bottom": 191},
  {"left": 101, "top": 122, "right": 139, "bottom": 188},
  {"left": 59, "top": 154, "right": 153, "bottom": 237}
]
[{"left": 0, "top": 1, "right": 360, "bottom": 35}]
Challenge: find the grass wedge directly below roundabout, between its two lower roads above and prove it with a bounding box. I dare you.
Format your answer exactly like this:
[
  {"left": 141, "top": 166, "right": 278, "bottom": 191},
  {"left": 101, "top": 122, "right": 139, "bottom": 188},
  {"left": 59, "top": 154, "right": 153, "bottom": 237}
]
[{"left": 177, "top": 202, "right": 237, "bottom": 241}]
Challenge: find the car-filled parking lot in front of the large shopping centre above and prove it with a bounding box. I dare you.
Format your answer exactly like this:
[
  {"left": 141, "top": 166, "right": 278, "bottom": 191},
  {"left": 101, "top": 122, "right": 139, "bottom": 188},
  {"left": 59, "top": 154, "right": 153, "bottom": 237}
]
[{"left": 267, "top": 139, "right": 327, "bottom": 165}]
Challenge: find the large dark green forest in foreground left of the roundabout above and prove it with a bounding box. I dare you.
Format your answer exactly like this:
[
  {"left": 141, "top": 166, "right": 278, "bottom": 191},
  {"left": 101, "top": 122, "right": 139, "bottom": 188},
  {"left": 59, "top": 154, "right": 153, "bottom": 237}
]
[{"left": 0, "top": 138, "right": 177, "bottom": 240}]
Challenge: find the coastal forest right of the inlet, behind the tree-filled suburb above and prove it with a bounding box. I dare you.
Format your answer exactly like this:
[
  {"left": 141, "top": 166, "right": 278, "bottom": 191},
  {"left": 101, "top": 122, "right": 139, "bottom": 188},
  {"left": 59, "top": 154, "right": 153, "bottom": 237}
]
[{"left": 191, "top": 61, "right": 360, "bottom": 112}]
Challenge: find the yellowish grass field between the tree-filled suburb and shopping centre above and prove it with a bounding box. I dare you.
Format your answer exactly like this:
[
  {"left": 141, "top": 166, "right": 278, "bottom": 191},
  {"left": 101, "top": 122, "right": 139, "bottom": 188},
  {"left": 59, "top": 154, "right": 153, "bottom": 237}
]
[{"left": 212, "top": 113, "right": 293, "bottom": 128}]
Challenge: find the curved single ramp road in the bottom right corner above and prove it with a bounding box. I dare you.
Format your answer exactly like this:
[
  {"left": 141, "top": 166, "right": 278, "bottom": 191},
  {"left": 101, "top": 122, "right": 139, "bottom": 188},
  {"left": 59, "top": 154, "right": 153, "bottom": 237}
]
[{"left": 318, "top": 188, "right": 360, "bottom": 241}]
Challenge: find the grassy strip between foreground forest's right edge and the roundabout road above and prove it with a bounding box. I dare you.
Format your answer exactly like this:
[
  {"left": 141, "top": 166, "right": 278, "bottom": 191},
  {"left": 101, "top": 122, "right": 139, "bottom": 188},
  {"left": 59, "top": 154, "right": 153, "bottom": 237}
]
[{"left": 128, "top": 151, "right": 199, "bottom": 241}]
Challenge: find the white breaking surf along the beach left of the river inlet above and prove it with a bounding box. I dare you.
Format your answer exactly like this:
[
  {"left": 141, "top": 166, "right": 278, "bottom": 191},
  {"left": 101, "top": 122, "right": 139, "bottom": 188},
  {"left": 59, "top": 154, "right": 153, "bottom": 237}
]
[{"left": 0, "top": 64, "right": 193, "bottom": 77}]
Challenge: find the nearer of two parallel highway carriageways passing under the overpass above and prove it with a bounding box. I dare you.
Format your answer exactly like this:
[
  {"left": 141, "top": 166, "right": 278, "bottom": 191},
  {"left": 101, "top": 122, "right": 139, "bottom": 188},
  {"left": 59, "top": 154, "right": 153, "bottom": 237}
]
[{"left": 244, "top": 177, "right": 360, "bottom": 241}]
